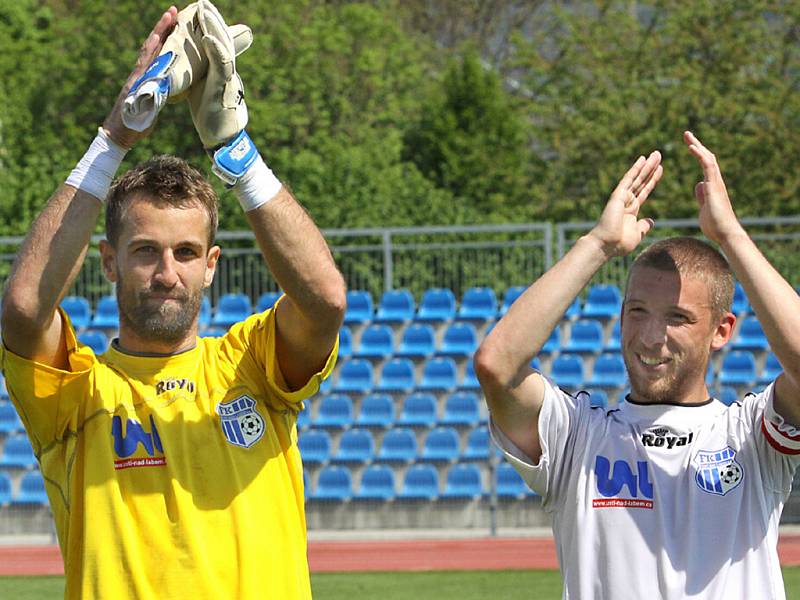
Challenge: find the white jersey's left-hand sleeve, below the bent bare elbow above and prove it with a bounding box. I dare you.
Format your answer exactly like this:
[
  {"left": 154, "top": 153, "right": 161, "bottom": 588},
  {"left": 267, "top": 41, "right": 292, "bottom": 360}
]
[{"left": 489, "top": 376, "right": 589, "bottom": 511}]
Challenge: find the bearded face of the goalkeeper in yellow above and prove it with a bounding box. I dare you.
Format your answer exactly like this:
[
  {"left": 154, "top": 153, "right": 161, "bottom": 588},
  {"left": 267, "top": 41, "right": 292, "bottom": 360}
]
[{"left": 100, "top": 195, "right": 220, "bottom": 353}]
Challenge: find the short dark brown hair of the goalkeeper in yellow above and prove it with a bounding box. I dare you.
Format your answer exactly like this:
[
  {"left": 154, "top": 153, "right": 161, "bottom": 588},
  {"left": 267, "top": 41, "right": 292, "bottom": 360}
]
[{"left": 106, "top": 154, "right": 218, "bottom": 248}]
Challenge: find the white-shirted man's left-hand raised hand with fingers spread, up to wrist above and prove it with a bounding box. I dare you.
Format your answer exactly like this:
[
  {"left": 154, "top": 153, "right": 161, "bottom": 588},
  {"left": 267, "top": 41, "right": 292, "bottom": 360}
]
[{"left": 589, "top": 150, "right": 664, "bottom": 256}]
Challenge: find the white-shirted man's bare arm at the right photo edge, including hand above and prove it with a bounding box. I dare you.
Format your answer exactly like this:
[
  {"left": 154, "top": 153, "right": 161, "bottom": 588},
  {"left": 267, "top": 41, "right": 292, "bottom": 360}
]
[{"left": 684, "top": 131, "right": 800, "bottom": 426}]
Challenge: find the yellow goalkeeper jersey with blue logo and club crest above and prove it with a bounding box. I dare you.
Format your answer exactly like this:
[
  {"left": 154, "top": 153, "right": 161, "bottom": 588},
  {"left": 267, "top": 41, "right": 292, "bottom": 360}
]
[{"left": 2, "top": 311, "right": 337, "bottom": 600}]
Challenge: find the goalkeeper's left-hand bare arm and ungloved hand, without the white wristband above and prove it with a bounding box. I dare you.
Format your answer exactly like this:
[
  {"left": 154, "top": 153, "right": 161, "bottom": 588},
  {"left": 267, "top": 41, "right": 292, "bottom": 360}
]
[{"left": 1, "top": 7, "right": 177, "bottom": 368}]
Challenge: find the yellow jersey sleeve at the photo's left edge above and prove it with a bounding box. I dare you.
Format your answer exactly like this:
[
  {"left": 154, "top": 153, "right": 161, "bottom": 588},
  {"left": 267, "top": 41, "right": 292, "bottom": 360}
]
[{"left": 0, "top": 309, "right": 97, "bottom": 448}]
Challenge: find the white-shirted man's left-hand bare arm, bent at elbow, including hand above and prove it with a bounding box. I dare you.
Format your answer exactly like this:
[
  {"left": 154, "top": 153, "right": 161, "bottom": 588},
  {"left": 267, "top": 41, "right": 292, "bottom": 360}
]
[{"left": 475, "top": 152, "right": 662, "bottom": 462}]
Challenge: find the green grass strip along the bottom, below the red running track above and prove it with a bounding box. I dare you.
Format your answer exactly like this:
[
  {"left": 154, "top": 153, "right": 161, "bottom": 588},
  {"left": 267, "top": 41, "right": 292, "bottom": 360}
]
[{"left": 0, "top": 567, "right": 800, "bottom": 600}]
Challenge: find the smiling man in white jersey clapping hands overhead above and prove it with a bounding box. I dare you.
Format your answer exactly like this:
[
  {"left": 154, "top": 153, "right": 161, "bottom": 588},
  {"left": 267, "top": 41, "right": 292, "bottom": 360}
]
[{"left": 475, "top": 132, "right": 800, "bottom": 600}]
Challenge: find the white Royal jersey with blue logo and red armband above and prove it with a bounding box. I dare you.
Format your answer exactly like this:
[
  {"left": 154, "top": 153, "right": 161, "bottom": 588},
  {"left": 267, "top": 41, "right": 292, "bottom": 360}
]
[{"left": 492, "top": 378, "right": 800, "bottom": 600}]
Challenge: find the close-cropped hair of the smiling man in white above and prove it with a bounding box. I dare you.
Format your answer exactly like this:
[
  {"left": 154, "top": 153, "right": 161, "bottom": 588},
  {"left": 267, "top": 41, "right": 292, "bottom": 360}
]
[{"left": 626, "top": 236, "right": 734, "bottom": 319}]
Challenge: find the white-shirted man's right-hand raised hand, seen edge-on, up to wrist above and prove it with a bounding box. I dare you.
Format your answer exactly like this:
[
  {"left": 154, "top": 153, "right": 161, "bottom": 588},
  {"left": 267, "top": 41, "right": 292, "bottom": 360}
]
[{"left": 683, "top": 131, "right": 742, "bottom": 244}]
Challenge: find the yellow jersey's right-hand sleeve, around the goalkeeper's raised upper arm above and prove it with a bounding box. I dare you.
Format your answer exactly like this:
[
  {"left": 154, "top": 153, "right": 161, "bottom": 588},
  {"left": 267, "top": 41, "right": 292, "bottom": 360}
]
[{"left": 225, "top": 296, "right": 339, "bottom": 410}]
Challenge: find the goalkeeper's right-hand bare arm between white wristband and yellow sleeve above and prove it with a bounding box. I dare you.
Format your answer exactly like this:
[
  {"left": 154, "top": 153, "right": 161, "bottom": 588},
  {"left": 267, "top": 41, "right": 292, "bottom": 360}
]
[{"left": 245, "top": 187, "right": 346, "bottom": 389}]
